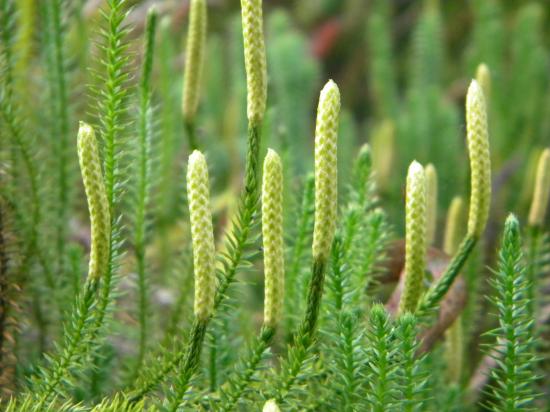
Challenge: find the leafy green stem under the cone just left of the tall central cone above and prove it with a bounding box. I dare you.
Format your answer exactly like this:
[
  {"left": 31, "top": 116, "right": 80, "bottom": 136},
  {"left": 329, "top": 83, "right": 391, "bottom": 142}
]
[{"left": 220, "top": 326, "right": 275, "bottom": 412}]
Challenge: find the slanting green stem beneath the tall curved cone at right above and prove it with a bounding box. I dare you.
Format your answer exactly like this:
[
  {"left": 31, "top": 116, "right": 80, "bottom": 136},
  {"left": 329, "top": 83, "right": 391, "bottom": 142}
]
[{"left": 416, "top": 235, "right": 478, "bottom": 318}]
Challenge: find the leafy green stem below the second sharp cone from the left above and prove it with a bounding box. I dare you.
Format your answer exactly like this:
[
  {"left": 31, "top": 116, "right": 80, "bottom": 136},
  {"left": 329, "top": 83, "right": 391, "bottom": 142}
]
[{"left": 168, "top": 318, "right": 210, "bottom": 412}]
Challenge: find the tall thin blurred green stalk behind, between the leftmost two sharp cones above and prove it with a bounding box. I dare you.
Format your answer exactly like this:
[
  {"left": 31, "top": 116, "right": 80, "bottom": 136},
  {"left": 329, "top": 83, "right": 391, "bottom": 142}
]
[{"left": 134, "top": 8, "right": 157, "bottom": 375}]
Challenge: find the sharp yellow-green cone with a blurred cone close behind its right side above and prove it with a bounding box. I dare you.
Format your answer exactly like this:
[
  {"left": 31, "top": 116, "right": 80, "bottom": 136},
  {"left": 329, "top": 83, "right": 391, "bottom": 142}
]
[{"left": 399, "top": 161, "right": 427, "bottom": 314}]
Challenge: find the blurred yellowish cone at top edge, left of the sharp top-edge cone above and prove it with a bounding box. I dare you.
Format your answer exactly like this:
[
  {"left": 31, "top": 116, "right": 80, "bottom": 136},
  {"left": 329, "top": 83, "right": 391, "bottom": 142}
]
[{"left": 182, "top": 0, "right": 207, "bottom": 151}]
